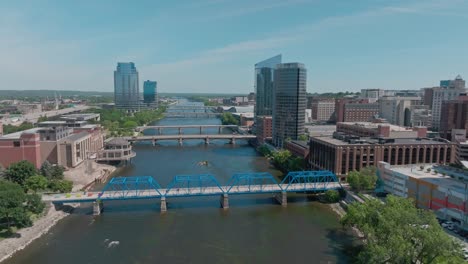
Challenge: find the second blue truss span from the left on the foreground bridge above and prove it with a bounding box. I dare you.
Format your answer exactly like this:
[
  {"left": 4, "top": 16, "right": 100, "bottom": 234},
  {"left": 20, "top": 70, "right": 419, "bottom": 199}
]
[{"left": 164, "top": 174, "right": 224, "bottom": 196}]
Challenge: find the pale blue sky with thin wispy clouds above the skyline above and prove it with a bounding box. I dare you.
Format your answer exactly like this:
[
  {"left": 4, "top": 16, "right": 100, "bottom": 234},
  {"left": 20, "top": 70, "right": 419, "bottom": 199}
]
[{"left": 0, "top": 0, "right": 468, "bottom": 93}]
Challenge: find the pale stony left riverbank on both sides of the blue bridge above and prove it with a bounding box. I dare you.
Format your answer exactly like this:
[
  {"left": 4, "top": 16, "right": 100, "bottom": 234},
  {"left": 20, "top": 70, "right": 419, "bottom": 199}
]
[{"left": 0, "top": 161, "right": 118, "bottom": 263}]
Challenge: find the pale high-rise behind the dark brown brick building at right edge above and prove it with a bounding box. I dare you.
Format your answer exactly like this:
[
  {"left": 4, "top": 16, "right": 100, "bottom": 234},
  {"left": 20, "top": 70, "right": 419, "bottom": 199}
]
[{"left": 432, "top": 76, "right": 466, "bottom": 130}]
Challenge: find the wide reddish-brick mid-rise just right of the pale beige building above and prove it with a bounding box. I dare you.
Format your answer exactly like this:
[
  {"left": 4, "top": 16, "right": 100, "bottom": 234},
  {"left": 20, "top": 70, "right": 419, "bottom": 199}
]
[{"left": 335, "top": 99, "right": 379, "bottom": 122}]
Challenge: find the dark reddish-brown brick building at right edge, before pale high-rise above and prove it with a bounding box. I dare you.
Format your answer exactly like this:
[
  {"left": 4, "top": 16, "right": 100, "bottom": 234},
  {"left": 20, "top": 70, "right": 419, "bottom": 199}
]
[{"left": 439, "top": 95, "right": 468, "bottom": 140}]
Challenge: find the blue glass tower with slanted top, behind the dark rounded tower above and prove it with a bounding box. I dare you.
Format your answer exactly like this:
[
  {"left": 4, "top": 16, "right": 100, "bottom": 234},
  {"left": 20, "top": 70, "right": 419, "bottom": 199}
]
[{"left": 255, "top": 54, "right": 281, "bottom": 116}]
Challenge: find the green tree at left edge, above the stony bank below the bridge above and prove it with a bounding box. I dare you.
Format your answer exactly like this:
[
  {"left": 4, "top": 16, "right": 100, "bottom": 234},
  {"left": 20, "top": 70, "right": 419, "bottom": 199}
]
[{"left": 0, "top": 180, "right": 32, "bottom": 229}]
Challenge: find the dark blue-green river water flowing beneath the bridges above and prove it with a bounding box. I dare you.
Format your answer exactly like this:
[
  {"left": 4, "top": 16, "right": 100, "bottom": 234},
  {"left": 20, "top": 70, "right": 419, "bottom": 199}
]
[{"left": 6, "top": 101, "right": 352, "bottom": 264}]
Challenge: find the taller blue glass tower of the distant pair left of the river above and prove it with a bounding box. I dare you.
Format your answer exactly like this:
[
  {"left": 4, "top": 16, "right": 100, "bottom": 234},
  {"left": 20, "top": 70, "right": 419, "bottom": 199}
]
[{"left": 114, "top": 62, "right": 140, "bottom": 112}]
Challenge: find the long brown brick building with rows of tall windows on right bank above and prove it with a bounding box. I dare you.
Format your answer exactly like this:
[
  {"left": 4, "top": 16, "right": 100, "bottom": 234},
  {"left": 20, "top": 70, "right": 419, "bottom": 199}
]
[{"left": 309, "top": 127, "right": 456, "bottom": 179}]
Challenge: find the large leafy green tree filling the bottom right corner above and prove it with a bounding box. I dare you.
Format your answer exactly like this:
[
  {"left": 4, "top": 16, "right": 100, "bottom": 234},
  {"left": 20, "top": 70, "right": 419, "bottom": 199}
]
[{"left": 341, "top": 195, "right": 463, "bottom": 263}]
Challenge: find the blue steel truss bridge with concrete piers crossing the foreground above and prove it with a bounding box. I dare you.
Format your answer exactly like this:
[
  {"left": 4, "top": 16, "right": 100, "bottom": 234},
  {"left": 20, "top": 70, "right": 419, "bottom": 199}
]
[{"left": 42, "top": 171, "right": 342, "bottom": 215}]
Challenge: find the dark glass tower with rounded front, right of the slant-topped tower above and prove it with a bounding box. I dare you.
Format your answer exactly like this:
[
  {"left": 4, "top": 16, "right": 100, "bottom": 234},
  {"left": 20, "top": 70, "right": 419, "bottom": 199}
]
[{"left": 273, "top": 63, "right": 307, "bottom": 147}]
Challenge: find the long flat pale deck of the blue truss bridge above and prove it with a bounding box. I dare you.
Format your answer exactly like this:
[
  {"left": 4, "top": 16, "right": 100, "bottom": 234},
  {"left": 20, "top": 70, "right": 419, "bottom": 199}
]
[{"left": 42, "top": 182, "right": 341, "bottom": 203}]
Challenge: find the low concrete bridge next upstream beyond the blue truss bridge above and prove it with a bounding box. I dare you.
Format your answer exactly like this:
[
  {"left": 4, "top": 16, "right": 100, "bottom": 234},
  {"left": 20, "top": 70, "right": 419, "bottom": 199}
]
[{"left": 122, "top": 134, "right": 257, "bottom": 146}]
